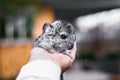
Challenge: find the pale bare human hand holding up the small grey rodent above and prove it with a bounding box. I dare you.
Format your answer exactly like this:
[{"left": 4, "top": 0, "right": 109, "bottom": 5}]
[{"left": 30, "top": 42, "right": 76, "bottom": 72}]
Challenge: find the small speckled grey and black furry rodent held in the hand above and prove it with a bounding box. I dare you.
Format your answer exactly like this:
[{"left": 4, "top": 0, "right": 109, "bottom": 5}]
[{"left": 34, "top": 20, "right": 76, "bottom": 53}]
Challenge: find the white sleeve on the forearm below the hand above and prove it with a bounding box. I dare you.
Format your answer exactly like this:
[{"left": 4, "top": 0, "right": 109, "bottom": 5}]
[{"left": 16, "top": 60, "right": 61, "bottom": 80}]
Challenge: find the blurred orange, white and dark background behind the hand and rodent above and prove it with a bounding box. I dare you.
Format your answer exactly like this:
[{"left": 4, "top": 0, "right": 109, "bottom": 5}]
[{"left": 0, "top": 0, "right": 120, "bottom": 80}]
